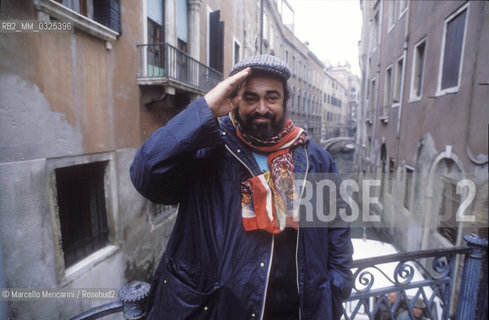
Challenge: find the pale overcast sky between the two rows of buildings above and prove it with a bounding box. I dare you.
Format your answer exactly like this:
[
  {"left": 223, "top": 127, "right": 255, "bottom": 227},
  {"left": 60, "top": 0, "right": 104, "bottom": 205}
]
[{"left": 288, "top": 0, "right": 362, "bottom": 75}]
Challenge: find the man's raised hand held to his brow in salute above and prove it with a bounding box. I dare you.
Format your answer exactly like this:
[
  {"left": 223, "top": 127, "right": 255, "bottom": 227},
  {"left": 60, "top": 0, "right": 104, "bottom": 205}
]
[{"left": 204, "top": 68, "right": 251, "bottom": 118}]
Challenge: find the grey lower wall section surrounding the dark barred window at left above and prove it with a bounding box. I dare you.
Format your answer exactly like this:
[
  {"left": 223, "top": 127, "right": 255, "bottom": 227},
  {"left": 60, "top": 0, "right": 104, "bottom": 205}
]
[{"left": 0, "top": 149, "right": 175, "bottom": 319}]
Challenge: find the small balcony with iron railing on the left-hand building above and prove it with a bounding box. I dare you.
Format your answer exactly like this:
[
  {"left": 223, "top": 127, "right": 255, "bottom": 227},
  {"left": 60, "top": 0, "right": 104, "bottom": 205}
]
[{"left": 137, "top": 43, "right": 222, "bottom": 94}]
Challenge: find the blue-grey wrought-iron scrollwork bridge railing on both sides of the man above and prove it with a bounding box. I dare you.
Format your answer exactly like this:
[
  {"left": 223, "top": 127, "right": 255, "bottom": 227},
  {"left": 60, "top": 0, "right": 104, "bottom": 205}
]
[{"left": 72, "top": 235, "right": 488, "bottom": 320}]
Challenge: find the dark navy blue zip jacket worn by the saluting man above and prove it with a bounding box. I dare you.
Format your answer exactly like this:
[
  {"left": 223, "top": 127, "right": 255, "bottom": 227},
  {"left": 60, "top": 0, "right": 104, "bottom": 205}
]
[{"left": 131, "top": 98, "right": 353, "bottom": 320}]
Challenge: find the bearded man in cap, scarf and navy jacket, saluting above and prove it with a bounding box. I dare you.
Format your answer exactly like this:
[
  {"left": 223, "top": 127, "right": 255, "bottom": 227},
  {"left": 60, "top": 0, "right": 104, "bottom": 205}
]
[{"left": 131, "top": 55, "right": 353, "bottom": 320}]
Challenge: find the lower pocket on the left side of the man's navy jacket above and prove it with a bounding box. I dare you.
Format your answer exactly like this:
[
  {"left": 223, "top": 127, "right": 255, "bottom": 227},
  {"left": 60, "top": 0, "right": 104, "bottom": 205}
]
[{"left": 148, "top": 268, "right": 220, "bottom": 320}]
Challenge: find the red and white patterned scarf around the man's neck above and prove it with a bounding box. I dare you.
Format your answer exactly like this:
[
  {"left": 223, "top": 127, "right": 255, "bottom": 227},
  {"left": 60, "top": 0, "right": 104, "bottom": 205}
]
[{"left": 231, "top": 117, "right": 309, "bottom": 233}]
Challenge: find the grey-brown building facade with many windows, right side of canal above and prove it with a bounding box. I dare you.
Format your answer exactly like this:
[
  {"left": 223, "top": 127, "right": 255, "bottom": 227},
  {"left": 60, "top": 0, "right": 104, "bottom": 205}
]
[{"left": 356, "top": 0, "right": 489, "bottom": 255}]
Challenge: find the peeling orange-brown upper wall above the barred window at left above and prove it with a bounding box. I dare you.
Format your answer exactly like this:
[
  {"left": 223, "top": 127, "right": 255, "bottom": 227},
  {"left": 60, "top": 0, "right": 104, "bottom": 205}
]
[{"left": 0, "top": 2, "right": 142, "bottom": 161}]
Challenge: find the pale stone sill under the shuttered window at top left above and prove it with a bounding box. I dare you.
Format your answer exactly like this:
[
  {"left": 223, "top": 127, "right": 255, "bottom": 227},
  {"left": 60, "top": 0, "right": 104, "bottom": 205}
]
[{"left": 34, "top": 0, "right": 119, "bottom": 41}]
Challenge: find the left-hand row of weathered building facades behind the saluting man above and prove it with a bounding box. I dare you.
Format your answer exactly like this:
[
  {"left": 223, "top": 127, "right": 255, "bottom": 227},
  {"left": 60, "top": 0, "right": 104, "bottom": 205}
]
[{"left": 0, "top": 0, "right": 345, "bottom": 319}]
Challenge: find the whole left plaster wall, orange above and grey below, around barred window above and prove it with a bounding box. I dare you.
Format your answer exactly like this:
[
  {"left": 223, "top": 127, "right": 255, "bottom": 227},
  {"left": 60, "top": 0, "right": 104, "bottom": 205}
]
[{"left": 0, "top": 0, "right": 175, "bottom": 319}]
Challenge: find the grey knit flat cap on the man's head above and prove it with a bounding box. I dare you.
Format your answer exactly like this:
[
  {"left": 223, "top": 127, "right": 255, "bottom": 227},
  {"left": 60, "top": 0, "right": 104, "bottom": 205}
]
[{"left": 229, "top": 54, "right": 291, "bottom": 81}]
